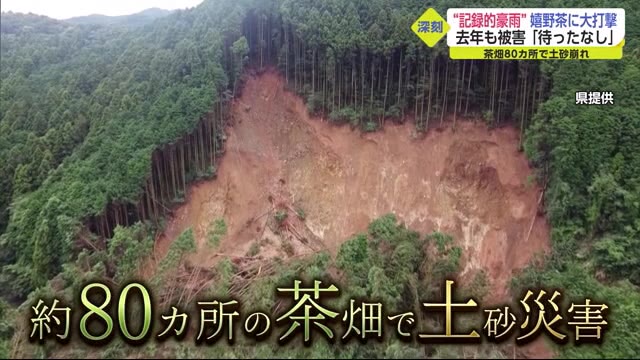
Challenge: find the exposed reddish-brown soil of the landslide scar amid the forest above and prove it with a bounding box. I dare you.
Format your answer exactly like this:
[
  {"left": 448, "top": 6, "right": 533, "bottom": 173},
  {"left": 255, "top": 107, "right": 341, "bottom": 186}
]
[{"left": 148, "top": 72, "right": 550, "bottom": 357}]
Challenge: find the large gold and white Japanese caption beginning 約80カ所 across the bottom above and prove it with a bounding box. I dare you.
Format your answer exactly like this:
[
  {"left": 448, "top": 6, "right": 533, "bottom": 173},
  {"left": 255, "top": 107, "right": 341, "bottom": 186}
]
[{"left": 28, "top": 279, "right": 609, "bottom": 346}]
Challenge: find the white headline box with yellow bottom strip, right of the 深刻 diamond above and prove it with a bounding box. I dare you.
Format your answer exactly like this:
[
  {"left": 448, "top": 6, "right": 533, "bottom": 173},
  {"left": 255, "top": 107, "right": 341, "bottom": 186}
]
[{"left": 447, "top": 8, "right": 625, "bottom": 60}]
